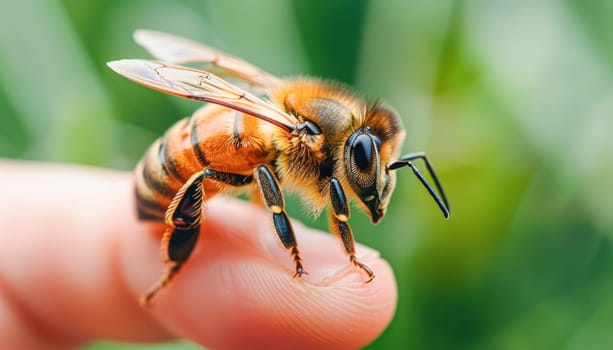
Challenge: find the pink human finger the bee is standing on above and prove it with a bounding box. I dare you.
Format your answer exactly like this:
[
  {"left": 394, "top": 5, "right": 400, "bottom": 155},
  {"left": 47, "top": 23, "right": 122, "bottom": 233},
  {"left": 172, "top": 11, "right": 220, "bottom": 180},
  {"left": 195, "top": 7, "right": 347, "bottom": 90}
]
[{"left": 0, "top": 161, "right": 396, "bottom": 349}]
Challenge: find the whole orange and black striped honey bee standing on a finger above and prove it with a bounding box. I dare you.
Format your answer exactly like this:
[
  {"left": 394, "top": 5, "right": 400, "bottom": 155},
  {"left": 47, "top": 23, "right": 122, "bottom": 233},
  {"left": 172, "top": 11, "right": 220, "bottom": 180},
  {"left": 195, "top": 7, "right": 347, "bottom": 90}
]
[{"left": 108, "top": 30, "right": 449, "bottom": 304}]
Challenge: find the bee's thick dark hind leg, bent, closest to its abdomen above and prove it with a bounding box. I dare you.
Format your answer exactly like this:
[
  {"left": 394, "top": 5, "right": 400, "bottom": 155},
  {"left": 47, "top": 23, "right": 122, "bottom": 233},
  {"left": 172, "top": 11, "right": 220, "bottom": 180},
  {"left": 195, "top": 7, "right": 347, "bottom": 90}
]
[{"left": 141, "top": 169, "right": 253, "bottom": 305}]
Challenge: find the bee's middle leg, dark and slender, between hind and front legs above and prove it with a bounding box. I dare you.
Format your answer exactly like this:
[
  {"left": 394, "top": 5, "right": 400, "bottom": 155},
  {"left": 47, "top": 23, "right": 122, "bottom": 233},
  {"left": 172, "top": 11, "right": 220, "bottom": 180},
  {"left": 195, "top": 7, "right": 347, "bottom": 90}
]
[{"left": 254, "top": 165, "right": 306, "bottom": 277}]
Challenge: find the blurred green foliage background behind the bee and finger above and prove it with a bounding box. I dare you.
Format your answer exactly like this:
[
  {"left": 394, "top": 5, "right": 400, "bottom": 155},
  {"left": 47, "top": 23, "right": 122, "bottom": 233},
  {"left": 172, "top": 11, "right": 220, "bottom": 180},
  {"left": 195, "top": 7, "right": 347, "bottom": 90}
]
[{"left": 0, "top": 0, "right": 613, "bottom": 350}]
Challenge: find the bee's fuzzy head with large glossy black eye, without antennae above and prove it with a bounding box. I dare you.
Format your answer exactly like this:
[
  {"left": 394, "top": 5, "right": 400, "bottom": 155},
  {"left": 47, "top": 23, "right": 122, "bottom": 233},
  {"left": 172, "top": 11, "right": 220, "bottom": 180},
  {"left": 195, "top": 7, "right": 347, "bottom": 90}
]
[{"left": 344, "top": 105, "right": 404, "bottom": 223}]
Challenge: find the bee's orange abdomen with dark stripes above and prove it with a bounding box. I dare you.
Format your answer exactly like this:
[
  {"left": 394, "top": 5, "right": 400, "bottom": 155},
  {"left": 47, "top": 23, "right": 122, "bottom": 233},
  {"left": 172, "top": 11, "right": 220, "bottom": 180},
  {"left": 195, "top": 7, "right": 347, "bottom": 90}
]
[{"left": 135, "top": 105, "right": 275, "bottom": 220}]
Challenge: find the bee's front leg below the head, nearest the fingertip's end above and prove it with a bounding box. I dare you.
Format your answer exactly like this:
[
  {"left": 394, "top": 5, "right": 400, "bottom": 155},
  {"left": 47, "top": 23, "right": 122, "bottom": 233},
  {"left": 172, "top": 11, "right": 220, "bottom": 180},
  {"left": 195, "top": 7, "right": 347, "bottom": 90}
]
[{"left": 330, "top": 178, "right": 375, "bottom": 283}]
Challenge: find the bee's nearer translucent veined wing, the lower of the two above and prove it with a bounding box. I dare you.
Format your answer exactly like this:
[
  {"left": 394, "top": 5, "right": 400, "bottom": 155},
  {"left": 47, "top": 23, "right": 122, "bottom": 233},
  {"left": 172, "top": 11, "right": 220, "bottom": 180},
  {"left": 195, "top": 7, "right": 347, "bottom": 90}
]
[{"left": 107, "top": 59, "right": 298, "bottom": 132}]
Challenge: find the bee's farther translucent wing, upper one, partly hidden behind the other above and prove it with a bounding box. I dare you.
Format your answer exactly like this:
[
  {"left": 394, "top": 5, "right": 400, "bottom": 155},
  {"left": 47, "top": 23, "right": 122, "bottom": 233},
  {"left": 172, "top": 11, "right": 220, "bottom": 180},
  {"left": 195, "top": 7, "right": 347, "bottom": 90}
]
[{"left": 134, "top": 29, "right": 279, "bottom": 87}]
